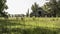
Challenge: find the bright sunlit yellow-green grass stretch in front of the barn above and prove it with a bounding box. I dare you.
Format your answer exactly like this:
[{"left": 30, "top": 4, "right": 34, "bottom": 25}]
[{"left": 8, "top": 18, "right": 60, "bottom": 28}]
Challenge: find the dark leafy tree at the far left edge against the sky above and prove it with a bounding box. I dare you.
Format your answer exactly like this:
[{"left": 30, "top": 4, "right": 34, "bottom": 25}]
[{"left": 0, "top": 0, "right": 8, "bottom": 17}]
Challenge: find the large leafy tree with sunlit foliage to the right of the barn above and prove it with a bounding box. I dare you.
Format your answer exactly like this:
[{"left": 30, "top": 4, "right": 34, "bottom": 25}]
[{"left": 43, "top": 0, "right": 60, "bottom": 17}]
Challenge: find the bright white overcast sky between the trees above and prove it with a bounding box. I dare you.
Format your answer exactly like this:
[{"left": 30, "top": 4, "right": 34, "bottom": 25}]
[{"left": 6, "top": 0, "right": 46, "bottom": 14}]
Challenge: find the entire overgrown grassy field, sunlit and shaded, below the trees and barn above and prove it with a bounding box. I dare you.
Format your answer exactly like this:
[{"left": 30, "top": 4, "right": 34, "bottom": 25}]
[{"left": 0, "top": 17, "right": 60, "bottom": 34}]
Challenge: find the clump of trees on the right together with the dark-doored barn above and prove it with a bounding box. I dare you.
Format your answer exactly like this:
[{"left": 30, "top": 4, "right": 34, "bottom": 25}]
[{"left": 30, "top": 0, "right": 60, "bottom": 17}]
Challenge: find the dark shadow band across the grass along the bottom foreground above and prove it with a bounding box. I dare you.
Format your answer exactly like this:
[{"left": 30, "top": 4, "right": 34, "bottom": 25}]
[{"left": 0, "top": 27, "right": 60, "bottom": 34}]
